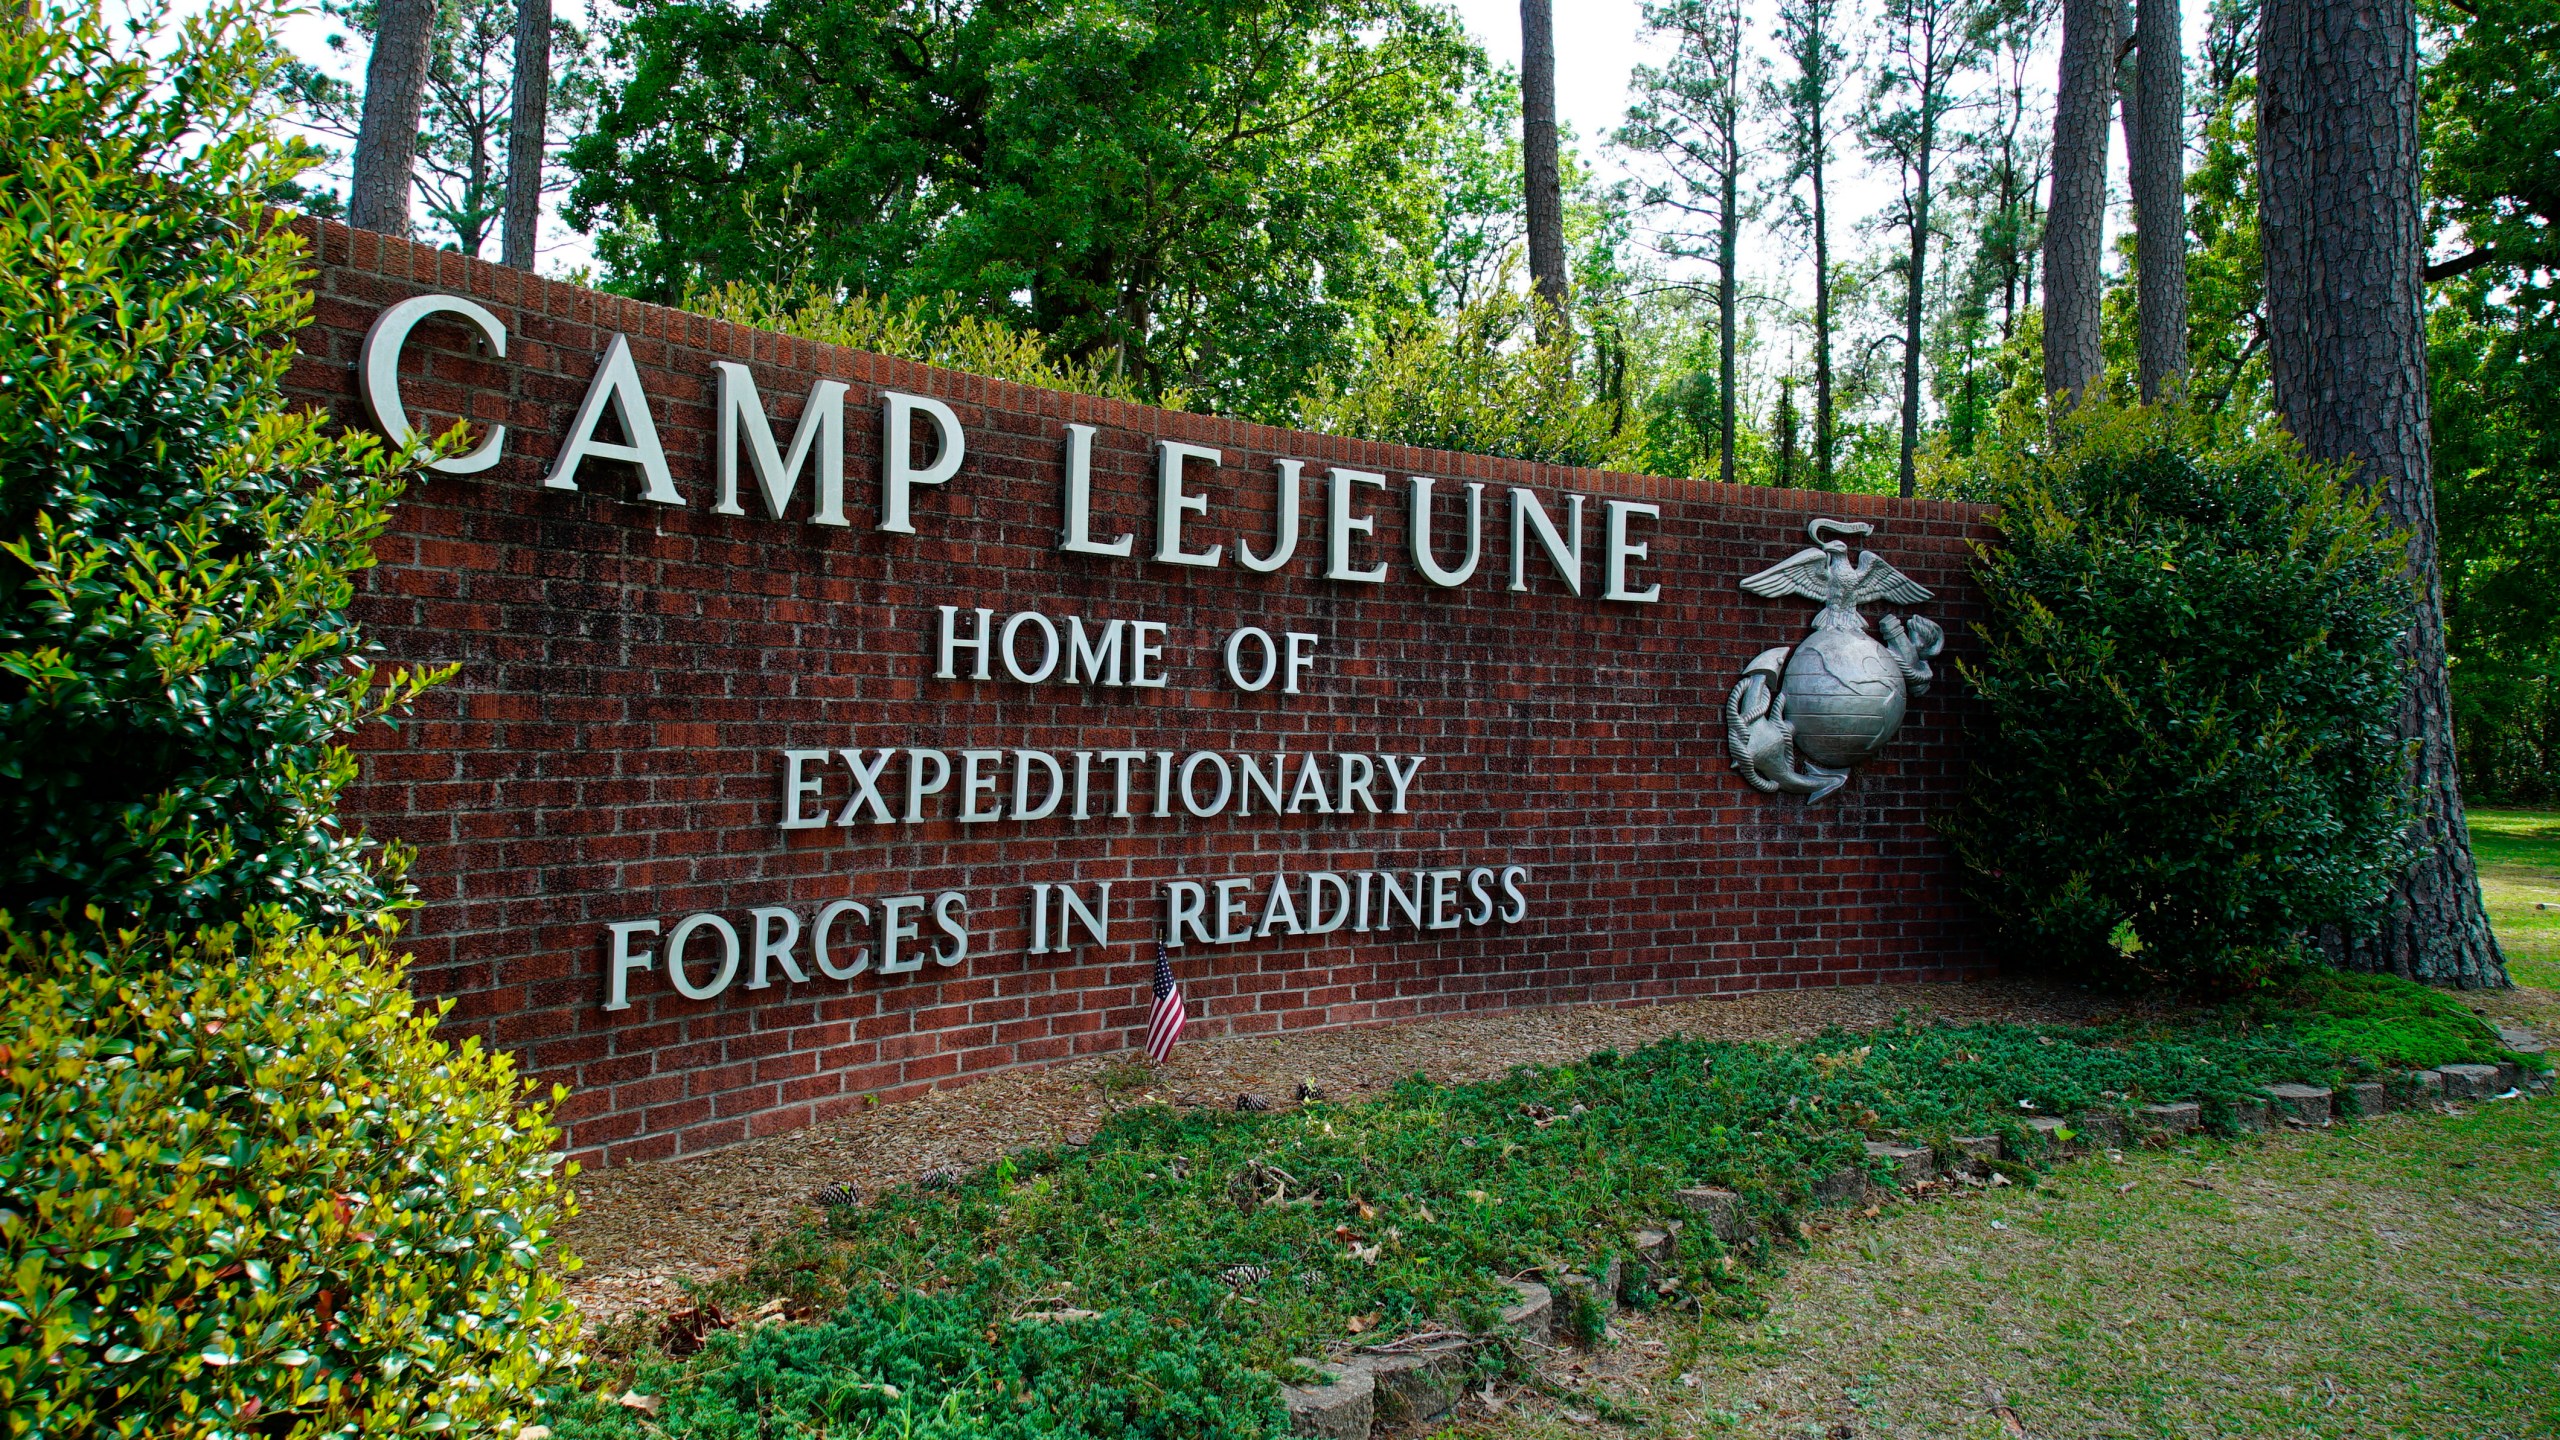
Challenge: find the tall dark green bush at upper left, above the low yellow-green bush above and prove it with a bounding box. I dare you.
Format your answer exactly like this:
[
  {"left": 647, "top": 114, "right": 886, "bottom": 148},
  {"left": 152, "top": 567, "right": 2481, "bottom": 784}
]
[{"left": 0, "top": 5, "right": 442, "bottom": 928}]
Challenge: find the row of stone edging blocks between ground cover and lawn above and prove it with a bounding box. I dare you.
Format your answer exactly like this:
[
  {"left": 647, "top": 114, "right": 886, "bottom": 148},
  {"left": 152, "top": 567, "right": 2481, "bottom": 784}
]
[{"left": 1280, "top": 1035, "right": 2555, "bottom": 1440}]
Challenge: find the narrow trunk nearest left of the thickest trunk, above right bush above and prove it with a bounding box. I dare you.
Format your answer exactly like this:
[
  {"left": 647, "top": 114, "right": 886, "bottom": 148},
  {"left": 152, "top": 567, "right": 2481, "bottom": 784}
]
[{"left": 2125, "top": 0, "right": 2186, "bottom": 402}]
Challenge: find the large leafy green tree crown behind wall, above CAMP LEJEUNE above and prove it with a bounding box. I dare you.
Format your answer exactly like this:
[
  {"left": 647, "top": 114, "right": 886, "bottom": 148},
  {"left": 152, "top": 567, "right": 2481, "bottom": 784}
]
[{"left": 568, "top": 0, "right": 1482, "bottom": 415}]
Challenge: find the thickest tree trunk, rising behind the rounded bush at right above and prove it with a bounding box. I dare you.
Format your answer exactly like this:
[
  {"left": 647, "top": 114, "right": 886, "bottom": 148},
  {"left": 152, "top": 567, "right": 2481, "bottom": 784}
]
[{"left": 2258, "top": 0, "right": 2506, "bottom": 989}]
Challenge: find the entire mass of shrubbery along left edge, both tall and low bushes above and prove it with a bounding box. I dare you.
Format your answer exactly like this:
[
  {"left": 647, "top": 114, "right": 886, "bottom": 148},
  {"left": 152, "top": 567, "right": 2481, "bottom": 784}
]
[{"left": 0, "top": 5, "right": 576, "bottom": 1440}]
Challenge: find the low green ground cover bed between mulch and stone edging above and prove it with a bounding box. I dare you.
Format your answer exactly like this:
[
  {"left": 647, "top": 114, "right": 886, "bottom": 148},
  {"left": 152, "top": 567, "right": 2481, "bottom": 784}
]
[{"left": 553, "top": 976, "right": 2504, "bottom": 1440}]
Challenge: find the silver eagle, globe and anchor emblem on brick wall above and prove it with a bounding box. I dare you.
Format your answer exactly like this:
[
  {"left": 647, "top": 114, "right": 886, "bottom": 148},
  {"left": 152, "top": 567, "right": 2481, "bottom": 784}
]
[{"left": 1725, "top": 520, "right": 1946, "bottom": 805}]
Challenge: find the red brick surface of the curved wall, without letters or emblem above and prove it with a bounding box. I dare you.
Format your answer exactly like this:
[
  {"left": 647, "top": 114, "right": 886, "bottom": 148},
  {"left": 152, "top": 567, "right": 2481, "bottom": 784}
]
[{"left": 292, "top": 228, "right": 1981, "bottom": 1163}]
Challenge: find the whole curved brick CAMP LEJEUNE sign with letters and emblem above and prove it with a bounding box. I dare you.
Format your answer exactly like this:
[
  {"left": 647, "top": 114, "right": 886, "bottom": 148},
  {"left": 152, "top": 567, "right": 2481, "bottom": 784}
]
[{"left": 292, "top": 228, "right": 1984, "bottom": 1163}]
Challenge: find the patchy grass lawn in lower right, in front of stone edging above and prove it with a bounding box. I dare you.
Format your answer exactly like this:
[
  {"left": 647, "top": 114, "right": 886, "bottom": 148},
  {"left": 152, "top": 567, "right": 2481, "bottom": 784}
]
[{"left": 1469, "top": 1102, "right": 2560, "bottom": 1440}]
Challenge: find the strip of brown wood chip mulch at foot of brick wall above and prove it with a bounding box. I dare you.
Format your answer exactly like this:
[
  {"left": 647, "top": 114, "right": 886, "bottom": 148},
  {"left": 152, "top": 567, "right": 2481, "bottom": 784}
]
[{"left": 561, "top": 981, "right": 2122, "bottom": 1325}]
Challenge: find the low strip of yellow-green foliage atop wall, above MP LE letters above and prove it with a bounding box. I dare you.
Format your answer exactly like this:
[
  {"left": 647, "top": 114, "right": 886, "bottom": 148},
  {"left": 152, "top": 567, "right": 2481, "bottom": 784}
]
[{"left": 684, "top": 284, "right": 1162, "bottom": 407}]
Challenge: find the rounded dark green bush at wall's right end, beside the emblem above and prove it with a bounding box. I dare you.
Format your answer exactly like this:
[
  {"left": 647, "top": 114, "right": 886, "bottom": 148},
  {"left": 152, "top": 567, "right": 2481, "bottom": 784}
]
[{"left": 1946, "top": 405, "right": 2409, "bottom": 986}]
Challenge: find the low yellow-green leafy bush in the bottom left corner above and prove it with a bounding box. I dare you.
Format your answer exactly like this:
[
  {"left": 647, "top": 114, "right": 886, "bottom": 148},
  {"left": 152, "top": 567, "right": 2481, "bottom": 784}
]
[{"left": 0, "top": 915, "right": 576, "bottom": 1440}]
